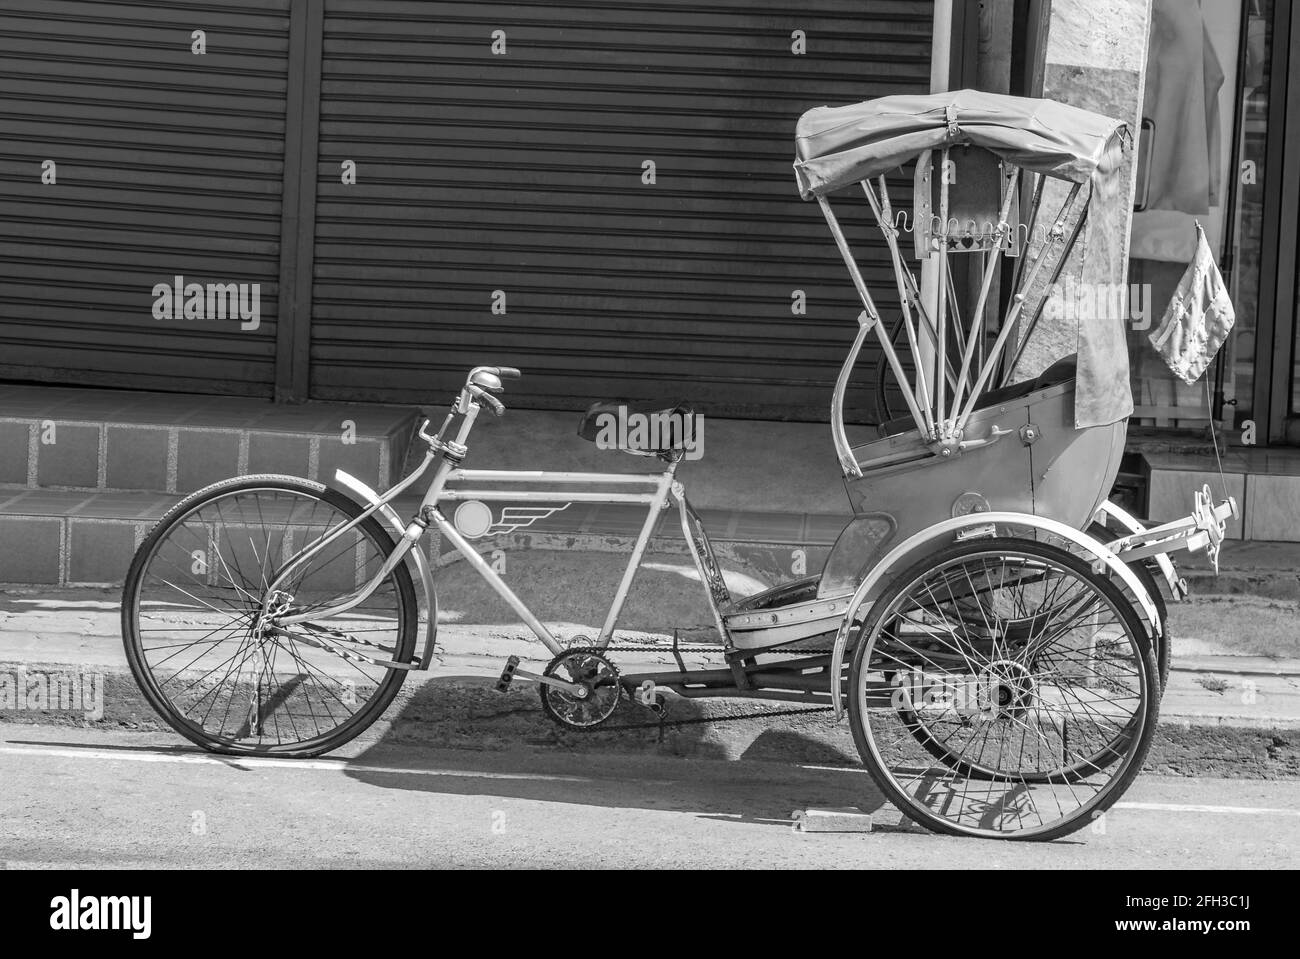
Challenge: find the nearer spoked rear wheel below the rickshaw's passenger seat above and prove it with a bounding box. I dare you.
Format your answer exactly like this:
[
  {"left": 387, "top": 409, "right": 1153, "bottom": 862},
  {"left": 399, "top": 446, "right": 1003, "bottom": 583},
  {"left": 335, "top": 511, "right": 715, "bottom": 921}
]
[{"left": 849, "top": 538, "right": 1158, "bottom": 839}]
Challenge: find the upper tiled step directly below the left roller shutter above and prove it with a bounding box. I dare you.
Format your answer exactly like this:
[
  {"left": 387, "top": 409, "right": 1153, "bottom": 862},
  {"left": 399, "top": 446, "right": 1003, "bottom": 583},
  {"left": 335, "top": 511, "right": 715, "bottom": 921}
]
[{"left": 0, "top": 386, "right": 416, "bottom": 494}]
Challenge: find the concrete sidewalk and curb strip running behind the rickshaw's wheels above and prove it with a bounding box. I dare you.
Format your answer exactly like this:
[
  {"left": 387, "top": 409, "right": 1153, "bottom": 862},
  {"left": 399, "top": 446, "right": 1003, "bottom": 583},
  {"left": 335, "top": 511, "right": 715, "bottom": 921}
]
[{"left": 0, "top": 566, "right": 1300, "bottom": 778}]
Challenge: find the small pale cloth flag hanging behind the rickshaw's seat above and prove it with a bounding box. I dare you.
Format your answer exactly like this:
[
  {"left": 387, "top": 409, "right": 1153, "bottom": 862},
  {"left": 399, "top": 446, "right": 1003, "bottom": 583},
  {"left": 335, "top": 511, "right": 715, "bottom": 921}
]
[{"left": 1151, "top": 221, "right": 1236, "bottom": 383}]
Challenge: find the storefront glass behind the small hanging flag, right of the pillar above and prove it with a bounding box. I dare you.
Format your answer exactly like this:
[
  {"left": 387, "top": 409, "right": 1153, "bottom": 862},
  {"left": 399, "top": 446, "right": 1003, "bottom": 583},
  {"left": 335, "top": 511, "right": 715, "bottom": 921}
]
[{"left": 1128, "top": 0, "right": 1273, "bottom": 428}]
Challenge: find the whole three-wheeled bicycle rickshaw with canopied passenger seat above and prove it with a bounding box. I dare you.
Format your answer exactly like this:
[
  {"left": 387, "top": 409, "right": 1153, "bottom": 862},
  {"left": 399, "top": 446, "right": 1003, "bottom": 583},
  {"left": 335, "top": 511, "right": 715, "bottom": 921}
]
[{"left": 122, "top": 91, "right": 1236, "bottom": 839}]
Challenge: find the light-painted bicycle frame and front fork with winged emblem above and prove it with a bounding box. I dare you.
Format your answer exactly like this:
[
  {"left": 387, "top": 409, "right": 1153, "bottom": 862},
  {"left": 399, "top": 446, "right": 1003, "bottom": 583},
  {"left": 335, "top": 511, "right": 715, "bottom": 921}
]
[{"left": 263, "top": 391, "right": 729, "bottom": 669}]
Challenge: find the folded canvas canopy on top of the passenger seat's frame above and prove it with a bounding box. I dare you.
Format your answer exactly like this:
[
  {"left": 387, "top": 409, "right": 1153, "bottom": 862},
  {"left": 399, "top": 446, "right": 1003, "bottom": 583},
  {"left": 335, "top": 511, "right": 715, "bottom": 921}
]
[{"left": 794, "top": 90, "right": 1128, "bottom": 200}]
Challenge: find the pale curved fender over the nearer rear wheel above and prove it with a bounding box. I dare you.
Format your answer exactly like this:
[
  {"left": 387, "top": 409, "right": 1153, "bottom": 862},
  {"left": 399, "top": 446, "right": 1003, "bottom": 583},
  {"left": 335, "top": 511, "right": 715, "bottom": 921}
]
[{"left": 831, "top": 512, "right": 1161, "bottom": 721}]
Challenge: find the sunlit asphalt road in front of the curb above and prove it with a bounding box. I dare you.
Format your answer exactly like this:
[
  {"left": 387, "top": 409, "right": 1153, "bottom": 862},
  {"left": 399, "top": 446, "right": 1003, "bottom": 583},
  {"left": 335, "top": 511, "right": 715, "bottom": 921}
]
[{"left": 0, "top": 724, "right": 1300, "bottom": 869}]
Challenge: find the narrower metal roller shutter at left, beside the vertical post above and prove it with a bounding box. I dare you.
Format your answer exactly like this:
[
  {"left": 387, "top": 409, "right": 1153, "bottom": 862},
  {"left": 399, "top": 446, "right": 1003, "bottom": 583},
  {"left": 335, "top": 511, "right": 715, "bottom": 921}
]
[{"left": 0, "top": 0, "right": 289, "bottom": 395}]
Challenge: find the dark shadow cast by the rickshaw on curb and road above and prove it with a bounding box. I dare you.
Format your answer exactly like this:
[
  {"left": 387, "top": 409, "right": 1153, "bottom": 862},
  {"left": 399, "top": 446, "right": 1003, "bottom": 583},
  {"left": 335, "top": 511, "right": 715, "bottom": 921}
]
[{"left": 335, "top": 676, "right": 883, "bottom": 828}]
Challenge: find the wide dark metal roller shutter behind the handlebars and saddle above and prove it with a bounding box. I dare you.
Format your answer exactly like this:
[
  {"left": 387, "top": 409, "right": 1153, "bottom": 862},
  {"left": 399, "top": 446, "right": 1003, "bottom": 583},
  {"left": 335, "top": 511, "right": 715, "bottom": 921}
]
[{"left": 312, "top": 0, "right": 933, "bottom": 418}]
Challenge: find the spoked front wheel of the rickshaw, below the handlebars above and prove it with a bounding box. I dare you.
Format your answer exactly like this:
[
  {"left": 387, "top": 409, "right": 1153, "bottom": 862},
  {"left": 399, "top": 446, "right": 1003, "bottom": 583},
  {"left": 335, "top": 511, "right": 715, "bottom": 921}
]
[{"left": 122, "top": 476, "right": 420, "bottom": 758}]
